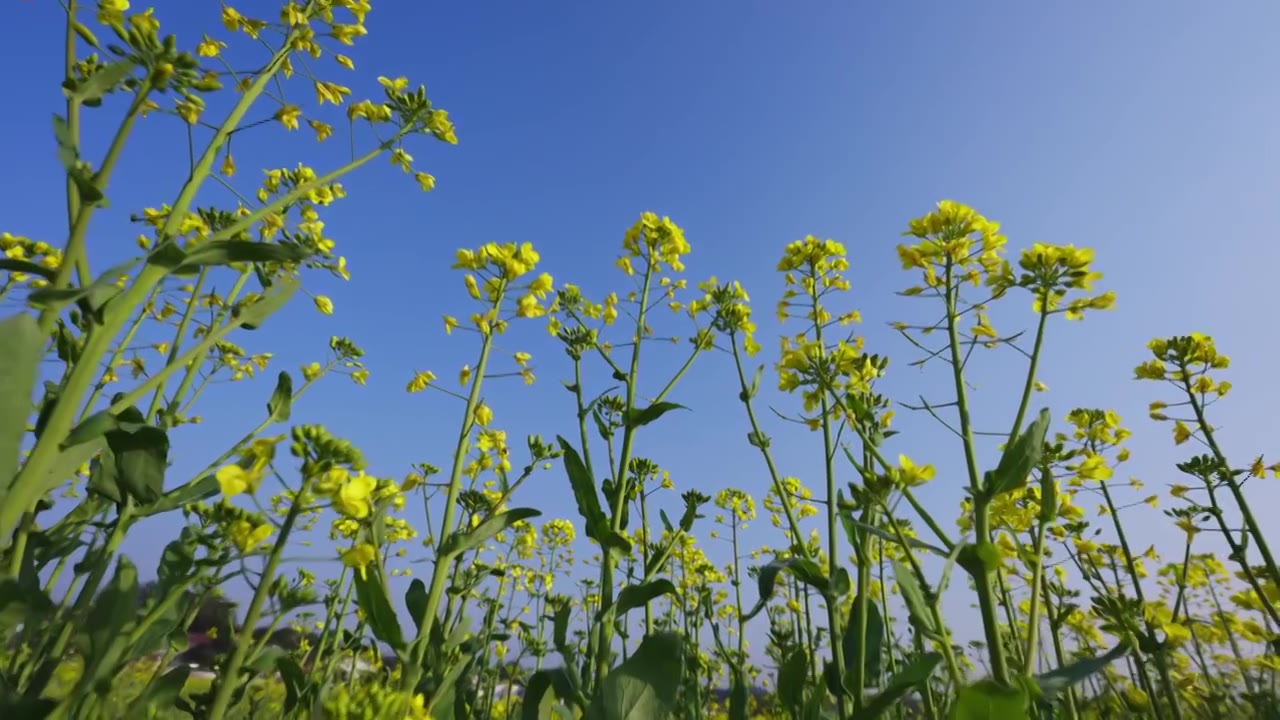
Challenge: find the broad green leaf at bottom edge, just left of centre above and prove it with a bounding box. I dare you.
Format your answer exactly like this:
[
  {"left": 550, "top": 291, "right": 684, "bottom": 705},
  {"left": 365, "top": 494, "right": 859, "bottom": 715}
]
[{"left": 582, "top": 633, "right": 685, "bottom": 720}]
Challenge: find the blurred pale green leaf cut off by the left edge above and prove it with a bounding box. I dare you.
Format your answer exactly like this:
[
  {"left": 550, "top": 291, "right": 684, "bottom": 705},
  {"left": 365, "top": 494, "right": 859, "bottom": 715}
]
[{"left": 0, "top": 313, "right": 45, "bottom": 489}]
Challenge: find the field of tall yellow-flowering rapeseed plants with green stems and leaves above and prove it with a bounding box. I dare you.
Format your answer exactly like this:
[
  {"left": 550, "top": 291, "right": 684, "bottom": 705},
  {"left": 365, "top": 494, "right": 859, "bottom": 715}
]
[{"left": 0, "top": 0, "right": 1280, "bottom": 720}]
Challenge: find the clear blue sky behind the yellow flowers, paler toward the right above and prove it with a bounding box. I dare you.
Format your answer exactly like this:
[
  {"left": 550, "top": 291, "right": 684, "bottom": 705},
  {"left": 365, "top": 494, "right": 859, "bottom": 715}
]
[{"left": 0, "top": 0, "right": 1280, "bottom": 650}]
